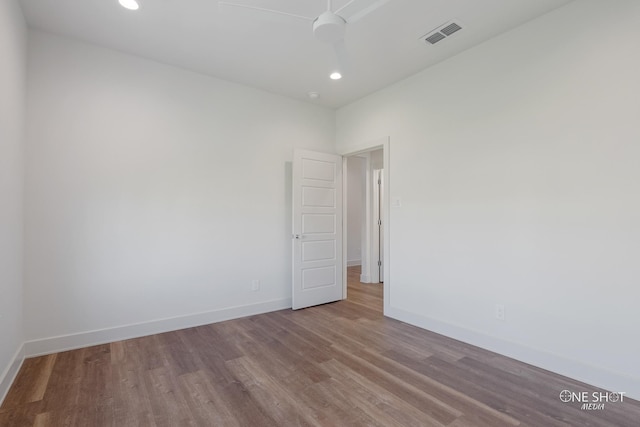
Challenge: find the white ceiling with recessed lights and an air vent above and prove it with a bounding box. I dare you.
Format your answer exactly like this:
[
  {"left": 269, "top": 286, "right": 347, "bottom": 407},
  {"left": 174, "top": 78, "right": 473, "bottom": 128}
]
[{"left": 21, "top": 0, "right": 571, "bottom": 108}]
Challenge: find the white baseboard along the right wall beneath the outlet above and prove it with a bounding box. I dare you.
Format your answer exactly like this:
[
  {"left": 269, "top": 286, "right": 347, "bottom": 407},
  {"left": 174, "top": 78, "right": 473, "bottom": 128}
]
[{"left": 385, "top": 307, "right": 640, "bottom": 400}]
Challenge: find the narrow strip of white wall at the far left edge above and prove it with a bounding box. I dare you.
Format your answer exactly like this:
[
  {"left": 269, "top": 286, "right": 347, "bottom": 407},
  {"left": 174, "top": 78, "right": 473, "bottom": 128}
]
[{"left": 0, "top": 0, "right": 27, "bottom": 402}]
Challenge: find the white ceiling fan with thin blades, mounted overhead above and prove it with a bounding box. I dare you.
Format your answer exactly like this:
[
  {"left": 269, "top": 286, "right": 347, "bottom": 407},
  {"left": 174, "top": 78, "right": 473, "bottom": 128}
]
[{"left": 218, "top": 0, "right": 391, "bottom": 75}]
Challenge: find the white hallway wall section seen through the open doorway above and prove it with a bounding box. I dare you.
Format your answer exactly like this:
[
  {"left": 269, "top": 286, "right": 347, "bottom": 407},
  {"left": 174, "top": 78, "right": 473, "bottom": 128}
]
[{"left": 347, "top": 156, "right": 366, "bottom": 265}]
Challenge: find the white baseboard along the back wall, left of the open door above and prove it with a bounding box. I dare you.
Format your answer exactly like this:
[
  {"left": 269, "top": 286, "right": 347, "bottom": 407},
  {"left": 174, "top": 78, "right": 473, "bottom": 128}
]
[{"left": 24, "top": 298, "right": 291, "bottom": 357}]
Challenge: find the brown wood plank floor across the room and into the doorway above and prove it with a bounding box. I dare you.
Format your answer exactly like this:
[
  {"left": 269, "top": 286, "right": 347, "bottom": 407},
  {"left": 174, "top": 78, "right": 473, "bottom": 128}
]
[{"left": 0, "top": 268, "right": 640, "bottom": 427}]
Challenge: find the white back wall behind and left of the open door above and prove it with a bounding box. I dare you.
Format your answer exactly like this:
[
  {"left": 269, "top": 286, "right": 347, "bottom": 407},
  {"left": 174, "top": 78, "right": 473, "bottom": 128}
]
[{"left": 25, "top": 32, "right": 335, "bottom": 354}]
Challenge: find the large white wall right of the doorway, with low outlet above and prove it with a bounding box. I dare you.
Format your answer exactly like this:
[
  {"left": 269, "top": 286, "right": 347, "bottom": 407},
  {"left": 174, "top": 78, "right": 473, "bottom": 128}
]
[{"left": 337, "top": 0, "right": 640, "bottom": 398}]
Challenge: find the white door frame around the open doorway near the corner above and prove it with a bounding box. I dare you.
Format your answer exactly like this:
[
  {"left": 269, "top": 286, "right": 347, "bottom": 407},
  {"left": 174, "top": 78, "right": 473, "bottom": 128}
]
[{"left": 338, "top": 136, "right": 391, "bottom": 315}]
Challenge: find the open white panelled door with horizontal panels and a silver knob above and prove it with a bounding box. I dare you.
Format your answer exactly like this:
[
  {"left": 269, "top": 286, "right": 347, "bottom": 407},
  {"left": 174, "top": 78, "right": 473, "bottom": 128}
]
[{"left": 292, "top": 150, "right": 343, "bottom": 310}]
